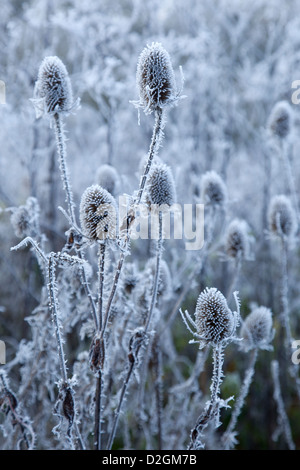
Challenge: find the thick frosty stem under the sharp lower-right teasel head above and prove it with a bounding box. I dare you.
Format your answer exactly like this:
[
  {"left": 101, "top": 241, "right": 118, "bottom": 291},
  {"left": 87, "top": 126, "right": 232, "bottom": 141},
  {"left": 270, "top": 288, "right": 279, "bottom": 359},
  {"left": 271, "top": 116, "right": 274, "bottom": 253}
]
[{"left": 188, "top": 344, "right": 224, "bottom": 450}]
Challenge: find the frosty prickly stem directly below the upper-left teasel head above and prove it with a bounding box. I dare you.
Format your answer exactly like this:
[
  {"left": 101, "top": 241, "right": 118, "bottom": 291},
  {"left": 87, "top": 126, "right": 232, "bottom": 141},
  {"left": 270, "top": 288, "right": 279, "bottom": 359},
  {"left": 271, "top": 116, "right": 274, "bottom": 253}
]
[{"left": 53, "top": 113, "right": 75, "bottom": 223}]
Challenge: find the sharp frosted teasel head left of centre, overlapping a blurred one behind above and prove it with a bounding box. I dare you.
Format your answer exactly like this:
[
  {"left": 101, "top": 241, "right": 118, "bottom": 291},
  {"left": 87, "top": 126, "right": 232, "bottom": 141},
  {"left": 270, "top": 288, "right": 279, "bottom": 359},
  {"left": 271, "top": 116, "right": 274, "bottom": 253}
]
[{"left": 80, "top": 184, "right": 117, "bottom": 241}]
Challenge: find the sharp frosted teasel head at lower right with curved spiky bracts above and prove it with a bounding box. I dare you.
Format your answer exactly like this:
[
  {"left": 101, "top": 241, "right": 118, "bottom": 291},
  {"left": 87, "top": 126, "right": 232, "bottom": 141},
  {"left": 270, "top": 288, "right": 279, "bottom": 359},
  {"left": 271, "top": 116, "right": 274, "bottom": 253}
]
[{"left": 195, "top": 287, "right": 234, "bottom": 347}]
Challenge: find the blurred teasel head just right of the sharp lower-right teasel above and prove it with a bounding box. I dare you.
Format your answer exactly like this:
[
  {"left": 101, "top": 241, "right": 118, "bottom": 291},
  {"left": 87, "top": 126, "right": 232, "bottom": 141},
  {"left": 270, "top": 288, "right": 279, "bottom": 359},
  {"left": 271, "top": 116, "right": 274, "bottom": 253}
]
[{"left": 241, "top": 307, "right": 274, "bottom": 351}]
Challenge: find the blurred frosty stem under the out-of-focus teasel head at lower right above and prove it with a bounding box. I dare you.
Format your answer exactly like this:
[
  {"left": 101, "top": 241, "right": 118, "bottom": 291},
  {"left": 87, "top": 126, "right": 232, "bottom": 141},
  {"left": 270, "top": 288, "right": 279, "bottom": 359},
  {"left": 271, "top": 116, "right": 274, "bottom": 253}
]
[{"left": 222, "top": 348, "right": 257, "bottom": 447}]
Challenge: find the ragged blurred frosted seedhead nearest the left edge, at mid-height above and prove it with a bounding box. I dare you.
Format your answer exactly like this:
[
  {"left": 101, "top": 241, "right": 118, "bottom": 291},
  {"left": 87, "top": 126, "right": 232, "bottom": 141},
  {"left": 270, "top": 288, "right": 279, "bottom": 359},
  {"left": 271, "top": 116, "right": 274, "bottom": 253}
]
[{"left": 8, "top": 197, "right": 40, "bottom": 238}]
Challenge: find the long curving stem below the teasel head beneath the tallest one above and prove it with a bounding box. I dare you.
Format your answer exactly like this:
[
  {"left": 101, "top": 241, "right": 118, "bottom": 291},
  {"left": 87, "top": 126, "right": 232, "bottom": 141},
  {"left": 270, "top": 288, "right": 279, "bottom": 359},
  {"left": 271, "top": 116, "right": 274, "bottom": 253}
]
[{"left": 107, "top": 212, "right": 162, "bottom": 450}]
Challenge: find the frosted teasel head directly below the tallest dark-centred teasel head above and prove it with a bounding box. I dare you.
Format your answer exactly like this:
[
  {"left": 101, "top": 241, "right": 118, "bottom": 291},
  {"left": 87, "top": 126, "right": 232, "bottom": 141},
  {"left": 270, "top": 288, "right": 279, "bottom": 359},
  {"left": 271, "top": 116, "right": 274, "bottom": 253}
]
[{"left": 146, "top": 163, "right": 176, "bottom": 206}]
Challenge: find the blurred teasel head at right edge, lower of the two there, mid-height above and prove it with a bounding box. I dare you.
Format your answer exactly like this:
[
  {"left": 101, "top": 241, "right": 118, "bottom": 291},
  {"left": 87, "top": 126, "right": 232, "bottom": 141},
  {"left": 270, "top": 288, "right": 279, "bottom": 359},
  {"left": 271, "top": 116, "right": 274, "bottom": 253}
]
[{"left": 269, "top": 194, "right": 297, "bottom": 237}]
